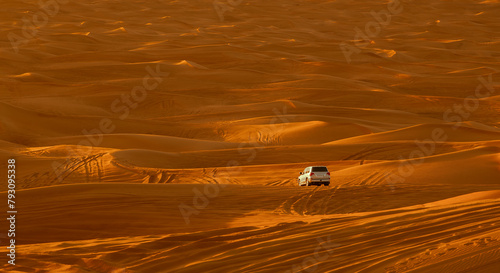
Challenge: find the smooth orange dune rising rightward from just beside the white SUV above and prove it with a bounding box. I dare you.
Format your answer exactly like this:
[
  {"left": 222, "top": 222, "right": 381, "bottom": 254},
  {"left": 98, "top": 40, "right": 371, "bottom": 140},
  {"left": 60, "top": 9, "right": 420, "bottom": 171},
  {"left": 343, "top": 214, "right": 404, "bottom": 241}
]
[{"left": 334, "top": 147, "right": 500, "bottom": 187}]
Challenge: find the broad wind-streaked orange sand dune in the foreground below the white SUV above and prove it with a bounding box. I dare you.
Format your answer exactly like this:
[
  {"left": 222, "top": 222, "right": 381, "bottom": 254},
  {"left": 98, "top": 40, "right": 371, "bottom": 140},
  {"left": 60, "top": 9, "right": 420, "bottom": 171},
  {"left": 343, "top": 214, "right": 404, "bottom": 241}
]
[{"left": 4, "top": 184, "right": 500, "bottom": 272}]
